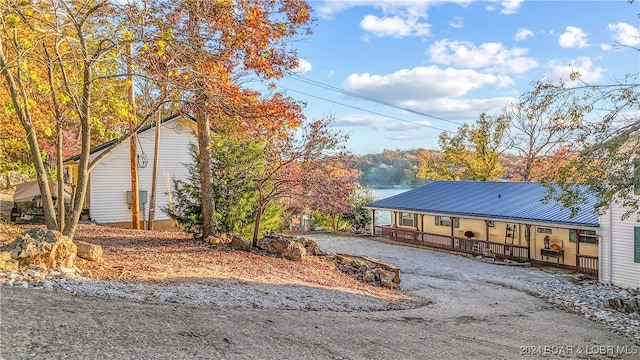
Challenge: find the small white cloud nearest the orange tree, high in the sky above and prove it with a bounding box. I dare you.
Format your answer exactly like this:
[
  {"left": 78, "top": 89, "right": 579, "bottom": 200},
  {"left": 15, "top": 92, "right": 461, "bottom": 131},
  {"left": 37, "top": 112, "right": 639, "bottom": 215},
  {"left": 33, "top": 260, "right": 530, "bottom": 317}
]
[{"left": 360, "top": 15, "right": 431, "bottom": 38}]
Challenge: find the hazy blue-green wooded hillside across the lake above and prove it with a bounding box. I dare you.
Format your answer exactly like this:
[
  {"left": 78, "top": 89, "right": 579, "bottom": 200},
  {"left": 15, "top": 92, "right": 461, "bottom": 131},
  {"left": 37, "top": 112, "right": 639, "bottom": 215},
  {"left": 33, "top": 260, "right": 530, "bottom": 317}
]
[{"left": 358, "top": 149, "right": 433, "bottom": 187}]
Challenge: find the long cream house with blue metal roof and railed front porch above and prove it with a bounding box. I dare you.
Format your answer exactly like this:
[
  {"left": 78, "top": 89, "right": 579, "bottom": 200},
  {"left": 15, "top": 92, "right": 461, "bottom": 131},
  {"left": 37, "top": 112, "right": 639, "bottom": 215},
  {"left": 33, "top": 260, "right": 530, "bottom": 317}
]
[{"left": 366, "top": 181, "right": 600, "bottom": 276}]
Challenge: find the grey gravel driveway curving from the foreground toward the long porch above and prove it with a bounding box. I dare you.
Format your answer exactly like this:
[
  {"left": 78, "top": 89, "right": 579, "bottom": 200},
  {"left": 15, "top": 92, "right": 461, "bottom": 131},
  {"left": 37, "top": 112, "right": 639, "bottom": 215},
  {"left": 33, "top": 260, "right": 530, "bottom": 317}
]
[{"left": 0, "top": 236, "right": 638, "bottom": 359}]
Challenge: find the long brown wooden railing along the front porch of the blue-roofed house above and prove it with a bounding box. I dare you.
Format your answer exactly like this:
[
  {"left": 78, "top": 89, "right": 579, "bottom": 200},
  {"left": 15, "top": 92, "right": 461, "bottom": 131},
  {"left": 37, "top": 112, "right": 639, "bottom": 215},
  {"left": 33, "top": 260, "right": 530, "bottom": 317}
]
[{"left": 374, "top": 226, "right": 530, "bottom": 261}]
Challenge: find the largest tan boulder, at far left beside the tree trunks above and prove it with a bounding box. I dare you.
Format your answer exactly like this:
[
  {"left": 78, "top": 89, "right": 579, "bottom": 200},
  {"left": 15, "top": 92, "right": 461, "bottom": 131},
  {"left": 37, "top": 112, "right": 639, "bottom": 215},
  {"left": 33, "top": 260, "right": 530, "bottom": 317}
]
[{"left": 0, "top": 228, "right": 78, "bottom": 268}]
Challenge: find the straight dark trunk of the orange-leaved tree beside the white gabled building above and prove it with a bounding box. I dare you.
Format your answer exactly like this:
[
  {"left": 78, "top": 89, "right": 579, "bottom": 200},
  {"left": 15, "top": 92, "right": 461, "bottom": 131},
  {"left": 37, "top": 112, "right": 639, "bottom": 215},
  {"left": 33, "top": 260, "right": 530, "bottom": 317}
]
[{"left": 197, "top": 109, "right": 216, "bottom": 239}]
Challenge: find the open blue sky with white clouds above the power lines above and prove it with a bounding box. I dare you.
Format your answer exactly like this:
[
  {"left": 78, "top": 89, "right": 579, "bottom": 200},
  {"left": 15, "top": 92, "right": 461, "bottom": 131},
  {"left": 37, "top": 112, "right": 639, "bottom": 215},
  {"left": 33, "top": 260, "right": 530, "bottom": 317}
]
[{"left": 258, "top": 0, "right": 640, "bottom": 154}]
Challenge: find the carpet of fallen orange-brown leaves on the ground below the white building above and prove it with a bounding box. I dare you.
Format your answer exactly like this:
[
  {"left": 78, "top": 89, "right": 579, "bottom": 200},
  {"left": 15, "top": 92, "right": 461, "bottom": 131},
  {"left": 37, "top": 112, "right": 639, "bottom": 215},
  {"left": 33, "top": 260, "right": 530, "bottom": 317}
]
[{"left": 0, "top": 225, "right": 409, "bottom": 300}]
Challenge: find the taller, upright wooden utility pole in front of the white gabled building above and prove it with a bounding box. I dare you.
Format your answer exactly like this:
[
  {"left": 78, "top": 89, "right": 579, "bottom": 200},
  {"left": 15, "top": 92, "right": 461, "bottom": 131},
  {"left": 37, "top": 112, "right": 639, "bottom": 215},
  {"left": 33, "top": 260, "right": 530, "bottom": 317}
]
[{"left": 127, "top": 43, "right": 140, "bottom": 229}]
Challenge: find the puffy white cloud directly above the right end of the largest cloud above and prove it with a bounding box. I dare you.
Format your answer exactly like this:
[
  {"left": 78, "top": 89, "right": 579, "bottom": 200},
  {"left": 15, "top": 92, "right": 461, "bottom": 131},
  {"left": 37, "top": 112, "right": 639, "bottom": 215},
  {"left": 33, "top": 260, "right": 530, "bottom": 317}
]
[{"left": 428, "top": 39, "right": 538, "bottom": 74}]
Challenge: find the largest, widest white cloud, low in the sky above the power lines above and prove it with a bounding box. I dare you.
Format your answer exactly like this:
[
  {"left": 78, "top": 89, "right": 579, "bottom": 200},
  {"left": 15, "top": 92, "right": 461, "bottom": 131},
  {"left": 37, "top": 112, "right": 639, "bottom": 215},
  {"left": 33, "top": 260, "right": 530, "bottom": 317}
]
[{"left": 344, "top": 66, "right": 504, "bottom": 104}]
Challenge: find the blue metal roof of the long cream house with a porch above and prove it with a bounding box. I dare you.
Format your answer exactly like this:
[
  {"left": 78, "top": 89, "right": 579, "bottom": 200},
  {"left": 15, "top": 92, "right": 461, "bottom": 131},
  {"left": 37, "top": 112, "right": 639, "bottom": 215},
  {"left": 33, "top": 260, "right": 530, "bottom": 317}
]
[{"left": 366, "top": 181, "right": 600, "bottom": 227}]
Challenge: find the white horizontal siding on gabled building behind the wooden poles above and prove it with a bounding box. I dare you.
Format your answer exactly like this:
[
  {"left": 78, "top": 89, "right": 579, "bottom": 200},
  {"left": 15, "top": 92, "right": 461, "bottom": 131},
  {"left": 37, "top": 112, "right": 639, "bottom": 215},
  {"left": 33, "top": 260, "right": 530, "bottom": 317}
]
[{"left": 89, "top": 118, "right": 197, "bottom": 223}]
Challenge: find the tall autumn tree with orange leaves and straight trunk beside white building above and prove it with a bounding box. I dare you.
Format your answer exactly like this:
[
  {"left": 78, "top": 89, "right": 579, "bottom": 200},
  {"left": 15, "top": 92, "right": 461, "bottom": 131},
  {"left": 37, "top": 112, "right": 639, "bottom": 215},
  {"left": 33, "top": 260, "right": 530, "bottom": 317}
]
[{"left": 122, "top": 0, "right": 310, "bottom": 237}]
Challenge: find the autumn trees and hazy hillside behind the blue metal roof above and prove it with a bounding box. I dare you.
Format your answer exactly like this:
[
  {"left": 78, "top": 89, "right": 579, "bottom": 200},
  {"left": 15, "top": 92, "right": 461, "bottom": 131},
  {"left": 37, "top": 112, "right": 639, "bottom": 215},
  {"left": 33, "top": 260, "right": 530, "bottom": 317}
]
[{"left": 359, "top": 67, "right": 640, "bottom": 221}]
